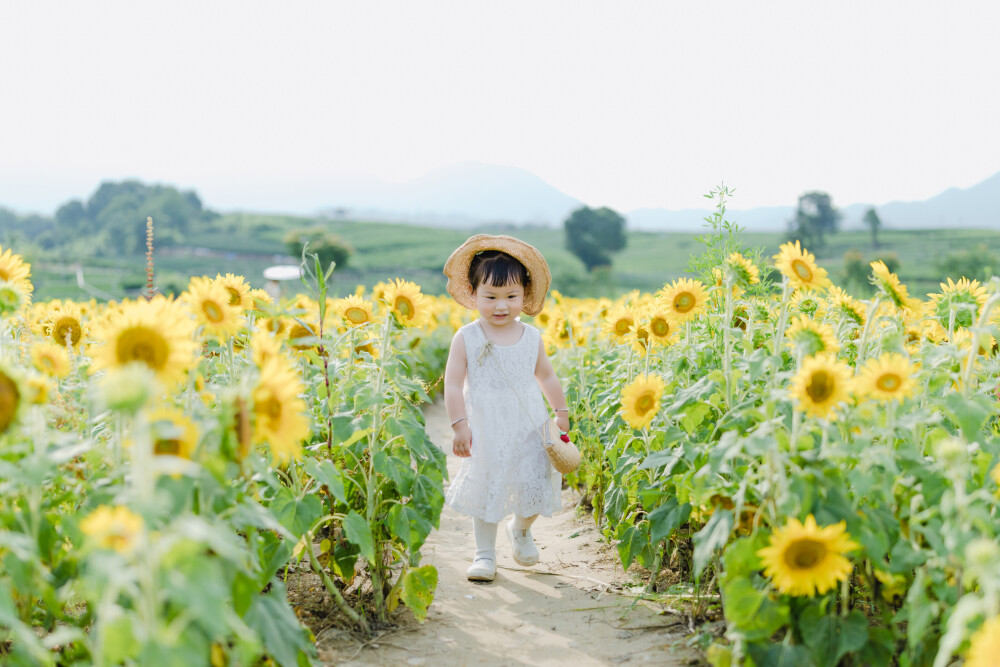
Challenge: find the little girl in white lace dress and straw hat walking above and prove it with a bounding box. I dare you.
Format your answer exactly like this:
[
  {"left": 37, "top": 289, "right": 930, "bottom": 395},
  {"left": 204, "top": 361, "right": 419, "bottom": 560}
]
[{"left": 444, "top": 234, "right": 569, "bottom": 581}]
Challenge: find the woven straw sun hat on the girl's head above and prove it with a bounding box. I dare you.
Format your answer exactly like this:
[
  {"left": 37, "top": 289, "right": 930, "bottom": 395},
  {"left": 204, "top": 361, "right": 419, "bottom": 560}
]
[{"left": 444, "top": 234, "right": 552, "bottom": 315}]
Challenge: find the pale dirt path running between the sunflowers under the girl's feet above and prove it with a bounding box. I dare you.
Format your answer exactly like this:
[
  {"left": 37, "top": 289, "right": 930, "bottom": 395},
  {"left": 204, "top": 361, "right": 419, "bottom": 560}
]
[{"left": 317, "top": 404, "right": 697, "bottom": 667}]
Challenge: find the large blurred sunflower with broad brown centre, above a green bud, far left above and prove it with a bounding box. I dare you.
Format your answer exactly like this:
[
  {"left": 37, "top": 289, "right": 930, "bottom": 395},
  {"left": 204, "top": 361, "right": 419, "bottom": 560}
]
[{"left": 91, "top": 296, "right": 195, "bottom": 386}]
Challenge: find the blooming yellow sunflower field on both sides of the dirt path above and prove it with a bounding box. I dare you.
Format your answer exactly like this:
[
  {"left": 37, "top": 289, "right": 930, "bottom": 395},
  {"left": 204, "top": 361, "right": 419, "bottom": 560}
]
[{"left": 0, "top": 190, "right": 1000, "bottom": 667}]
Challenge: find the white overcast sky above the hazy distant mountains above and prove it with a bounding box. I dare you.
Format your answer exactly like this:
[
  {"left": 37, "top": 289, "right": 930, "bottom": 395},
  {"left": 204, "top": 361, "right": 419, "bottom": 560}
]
[{"left": 0, "top": 0, "right": 1000, "bottom": 213}]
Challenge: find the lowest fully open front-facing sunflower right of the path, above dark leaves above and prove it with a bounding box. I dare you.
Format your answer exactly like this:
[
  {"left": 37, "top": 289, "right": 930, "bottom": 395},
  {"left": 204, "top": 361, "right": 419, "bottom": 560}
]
[{"left": 757, "top": 514, "right": 858, "bottom": 597}]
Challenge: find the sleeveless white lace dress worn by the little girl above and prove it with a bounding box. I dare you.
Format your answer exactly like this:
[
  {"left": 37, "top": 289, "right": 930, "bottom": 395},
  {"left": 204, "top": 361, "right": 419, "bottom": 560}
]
[{"left": 447, "top": 322, "right": 562, "bottom": 523}]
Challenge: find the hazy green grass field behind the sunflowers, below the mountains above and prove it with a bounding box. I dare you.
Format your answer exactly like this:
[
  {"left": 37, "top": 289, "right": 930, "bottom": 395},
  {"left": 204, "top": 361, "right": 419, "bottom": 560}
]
[{"left": 23, "top": 214, "right": 1000, "bottom": 300}]
